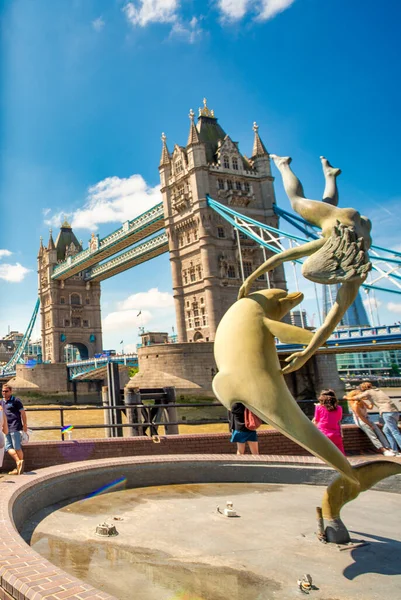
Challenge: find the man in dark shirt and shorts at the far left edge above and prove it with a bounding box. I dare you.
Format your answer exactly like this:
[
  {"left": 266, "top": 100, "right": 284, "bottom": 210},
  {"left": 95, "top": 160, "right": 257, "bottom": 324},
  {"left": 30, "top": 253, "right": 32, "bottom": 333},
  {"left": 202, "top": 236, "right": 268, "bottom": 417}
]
[{"left": 2, "top": 384, "right": 28, "bottom": 475}]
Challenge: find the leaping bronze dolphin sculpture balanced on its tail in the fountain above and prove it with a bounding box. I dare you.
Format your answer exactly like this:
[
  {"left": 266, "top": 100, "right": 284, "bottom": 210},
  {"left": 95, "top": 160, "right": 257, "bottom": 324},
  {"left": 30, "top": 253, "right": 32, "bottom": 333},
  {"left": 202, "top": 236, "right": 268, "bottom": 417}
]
[{"left": 213, "top": 289, "right": 401, "bottom": 543}]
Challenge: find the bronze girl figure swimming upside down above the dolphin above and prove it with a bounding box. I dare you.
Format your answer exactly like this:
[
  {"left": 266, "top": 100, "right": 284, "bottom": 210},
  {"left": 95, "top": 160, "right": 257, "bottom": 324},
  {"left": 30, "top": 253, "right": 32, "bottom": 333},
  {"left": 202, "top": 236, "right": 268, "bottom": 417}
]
[{"left": 238, "top": 154, "right": 371, "bottom": 373}]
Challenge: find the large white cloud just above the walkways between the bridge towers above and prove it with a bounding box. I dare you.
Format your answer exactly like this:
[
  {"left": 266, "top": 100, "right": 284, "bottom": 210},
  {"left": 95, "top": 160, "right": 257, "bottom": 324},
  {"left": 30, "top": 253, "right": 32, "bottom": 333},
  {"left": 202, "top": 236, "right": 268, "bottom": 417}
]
[{"left": 45, "top": 175, "right": 161, "bottom": 230}]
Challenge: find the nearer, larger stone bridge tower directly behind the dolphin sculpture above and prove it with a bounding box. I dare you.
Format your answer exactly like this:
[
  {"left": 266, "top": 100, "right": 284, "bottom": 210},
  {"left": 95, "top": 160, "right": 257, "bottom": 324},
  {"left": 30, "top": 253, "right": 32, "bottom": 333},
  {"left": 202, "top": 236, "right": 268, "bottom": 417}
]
[{"left": 159, "top": 100, "right": 286, "bottom": 342}]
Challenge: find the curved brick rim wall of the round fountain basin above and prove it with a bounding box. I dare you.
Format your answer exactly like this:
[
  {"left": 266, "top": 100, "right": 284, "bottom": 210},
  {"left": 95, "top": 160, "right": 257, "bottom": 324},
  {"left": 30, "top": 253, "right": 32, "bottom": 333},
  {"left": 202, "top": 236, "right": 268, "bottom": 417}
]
[{"left": 0, "top": 455, "right": 401, "bottom": 600}]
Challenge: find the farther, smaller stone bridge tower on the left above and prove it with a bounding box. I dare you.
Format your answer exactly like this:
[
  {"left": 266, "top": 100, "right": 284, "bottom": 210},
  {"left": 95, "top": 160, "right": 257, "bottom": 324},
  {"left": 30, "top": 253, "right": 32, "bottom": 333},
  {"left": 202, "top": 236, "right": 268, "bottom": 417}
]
[{"left": 38, "top": 221, "right": 102, "bottom": 363}]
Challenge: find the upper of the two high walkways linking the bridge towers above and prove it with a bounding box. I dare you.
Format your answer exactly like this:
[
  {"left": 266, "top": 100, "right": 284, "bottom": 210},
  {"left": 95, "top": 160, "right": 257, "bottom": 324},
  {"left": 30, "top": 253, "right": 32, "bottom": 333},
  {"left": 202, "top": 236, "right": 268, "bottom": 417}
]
[{"left": 52, "top": 202, "right": 164, "bottom": 280}]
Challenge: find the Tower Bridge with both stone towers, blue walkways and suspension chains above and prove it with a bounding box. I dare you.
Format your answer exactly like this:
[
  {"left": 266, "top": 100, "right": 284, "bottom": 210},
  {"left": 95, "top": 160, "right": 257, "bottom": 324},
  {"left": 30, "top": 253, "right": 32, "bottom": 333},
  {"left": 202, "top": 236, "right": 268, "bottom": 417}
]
[{"left": 5, "top": 101, "right": 401, "bottom": 398}]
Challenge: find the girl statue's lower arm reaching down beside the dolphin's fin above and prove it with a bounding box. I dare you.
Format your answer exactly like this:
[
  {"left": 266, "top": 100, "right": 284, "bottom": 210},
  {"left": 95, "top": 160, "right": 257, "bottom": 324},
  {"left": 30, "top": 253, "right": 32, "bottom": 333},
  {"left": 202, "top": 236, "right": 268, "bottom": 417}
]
[{"left": 283, "top": 279, "right": 363, "bottom": 373}]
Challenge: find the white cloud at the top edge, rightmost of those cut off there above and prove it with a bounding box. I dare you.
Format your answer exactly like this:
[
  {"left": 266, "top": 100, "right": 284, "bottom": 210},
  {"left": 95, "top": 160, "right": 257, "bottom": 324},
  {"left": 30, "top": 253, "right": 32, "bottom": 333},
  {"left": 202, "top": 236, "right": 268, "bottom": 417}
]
[{"left": 217, "top": 0, "right": 295, "bottom": 21}]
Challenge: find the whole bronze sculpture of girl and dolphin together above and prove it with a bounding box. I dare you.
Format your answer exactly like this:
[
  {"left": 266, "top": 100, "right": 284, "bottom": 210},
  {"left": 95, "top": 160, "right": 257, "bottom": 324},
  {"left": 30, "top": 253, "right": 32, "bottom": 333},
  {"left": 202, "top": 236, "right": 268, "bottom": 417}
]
[{"left": 213, "top": 156, "right": 401, "bottom": 543}]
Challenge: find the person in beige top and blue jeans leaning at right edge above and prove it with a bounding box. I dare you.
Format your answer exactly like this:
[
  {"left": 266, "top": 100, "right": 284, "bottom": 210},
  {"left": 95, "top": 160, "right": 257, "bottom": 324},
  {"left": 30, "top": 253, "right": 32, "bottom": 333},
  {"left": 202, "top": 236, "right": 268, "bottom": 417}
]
[{"left": 357, "top": 381, "right": 401, "bottom": 456}]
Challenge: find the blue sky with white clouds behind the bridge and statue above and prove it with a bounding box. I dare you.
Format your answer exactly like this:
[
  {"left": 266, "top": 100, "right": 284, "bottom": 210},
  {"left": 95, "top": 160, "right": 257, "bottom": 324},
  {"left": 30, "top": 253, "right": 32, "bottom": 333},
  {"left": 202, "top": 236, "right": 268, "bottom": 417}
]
[{"left": 0, "top": 0, "right": 401, "bottom": 348}]
